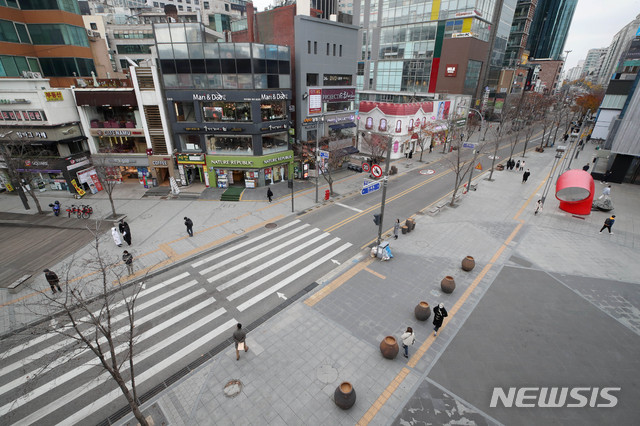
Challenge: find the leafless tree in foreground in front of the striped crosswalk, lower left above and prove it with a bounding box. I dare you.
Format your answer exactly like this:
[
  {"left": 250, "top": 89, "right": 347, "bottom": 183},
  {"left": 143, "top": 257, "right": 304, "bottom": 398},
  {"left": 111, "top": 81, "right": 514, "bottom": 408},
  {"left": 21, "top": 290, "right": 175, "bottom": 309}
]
[{"left": 8, "top": 225, "right": 148, "bottom": 425}]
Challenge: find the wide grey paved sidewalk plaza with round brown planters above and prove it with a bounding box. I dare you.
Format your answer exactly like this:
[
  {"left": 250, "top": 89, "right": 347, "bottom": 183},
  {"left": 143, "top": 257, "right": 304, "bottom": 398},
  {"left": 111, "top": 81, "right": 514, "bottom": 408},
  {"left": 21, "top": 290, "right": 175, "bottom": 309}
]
[{"left": 107, "top": 141, "right": 640, "bottom": 425}]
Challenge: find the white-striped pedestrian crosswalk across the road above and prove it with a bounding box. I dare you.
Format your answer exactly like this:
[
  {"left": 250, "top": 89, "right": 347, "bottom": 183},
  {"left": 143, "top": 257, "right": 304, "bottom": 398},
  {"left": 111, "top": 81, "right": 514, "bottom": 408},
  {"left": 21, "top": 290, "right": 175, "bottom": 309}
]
[{"left": 0, "top": 220, "right": 351, "bottom": 425}]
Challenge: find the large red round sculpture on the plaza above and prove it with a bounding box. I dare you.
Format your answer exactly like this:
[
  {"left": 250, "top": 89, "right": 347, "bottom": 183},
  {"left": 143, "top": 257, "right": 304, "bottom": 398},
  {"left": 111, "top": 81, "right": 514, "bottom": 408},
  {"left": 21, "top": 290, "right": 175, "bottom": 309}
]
[{"left": 556, "top": 169, "right": 595, "bottom": 215}]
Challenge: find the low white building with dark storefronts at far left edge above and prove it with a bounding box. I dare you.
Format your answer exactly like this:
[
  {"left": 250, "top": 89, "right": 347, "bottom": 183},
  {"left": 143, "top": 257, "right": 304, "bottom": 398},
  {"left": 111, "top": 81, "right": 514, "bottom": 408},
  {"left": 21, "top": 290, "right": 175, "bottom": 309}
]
[{"left": 0, "top": 78, "right": 92, "bottom": 193}]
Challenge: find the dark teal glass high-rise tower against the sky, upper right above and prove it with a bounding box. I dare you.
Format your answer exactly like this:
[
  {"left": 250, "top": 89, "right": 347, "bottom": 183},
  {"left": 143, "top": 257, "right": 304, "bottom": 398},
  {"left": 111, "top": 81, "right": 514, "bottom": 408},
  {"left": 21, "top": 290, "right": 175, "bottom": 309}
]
[{"left": 527, "top": 0, "right": 578, "bottom": 60}]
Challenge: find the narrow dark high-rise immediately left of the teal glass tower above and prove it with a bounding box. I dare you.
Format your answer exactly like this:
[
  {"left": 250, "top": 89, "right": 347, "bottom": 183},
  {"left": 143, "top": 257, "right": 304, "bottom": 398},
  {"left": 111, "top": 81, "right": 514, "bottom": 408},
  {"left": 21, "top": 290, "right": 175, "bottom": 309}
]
[{"left": 504, "top": 0, "right": 538, "bottom": 68}]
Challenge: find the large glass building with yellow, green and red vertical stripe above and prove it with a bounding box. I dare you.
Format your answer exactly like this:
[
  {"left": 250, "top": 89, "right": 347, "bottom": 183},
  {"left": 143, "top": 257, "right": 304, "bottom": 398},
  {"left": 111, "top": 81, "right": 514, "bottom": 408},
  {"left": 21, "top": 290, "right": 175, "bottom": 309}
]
[{"left": 354, "top": 0, "right": 516, "bottom": 102}]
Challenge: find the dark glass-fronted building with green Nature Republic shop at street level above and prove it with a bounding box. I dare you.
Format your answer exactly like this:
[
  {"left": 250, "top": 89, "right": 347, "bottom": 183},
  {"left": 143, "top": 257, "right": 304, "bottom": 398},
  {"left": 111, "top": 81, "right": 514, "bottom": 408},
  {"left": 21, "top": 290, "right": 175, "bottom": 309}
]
[{"left": 154, "top": 23, "right": 293, "bottom": 187}]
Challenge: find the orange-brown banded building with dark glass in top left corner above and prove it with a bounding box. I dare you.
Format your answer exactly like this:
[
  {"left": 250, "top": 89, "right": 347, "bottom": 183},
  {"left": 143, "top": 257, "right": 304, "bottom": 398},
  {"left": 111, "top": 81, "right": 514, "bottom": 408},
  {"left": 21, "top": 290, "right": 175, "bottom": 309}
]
[{"left": 0, "top": 0, "right": 96, "bottom": 87}]
